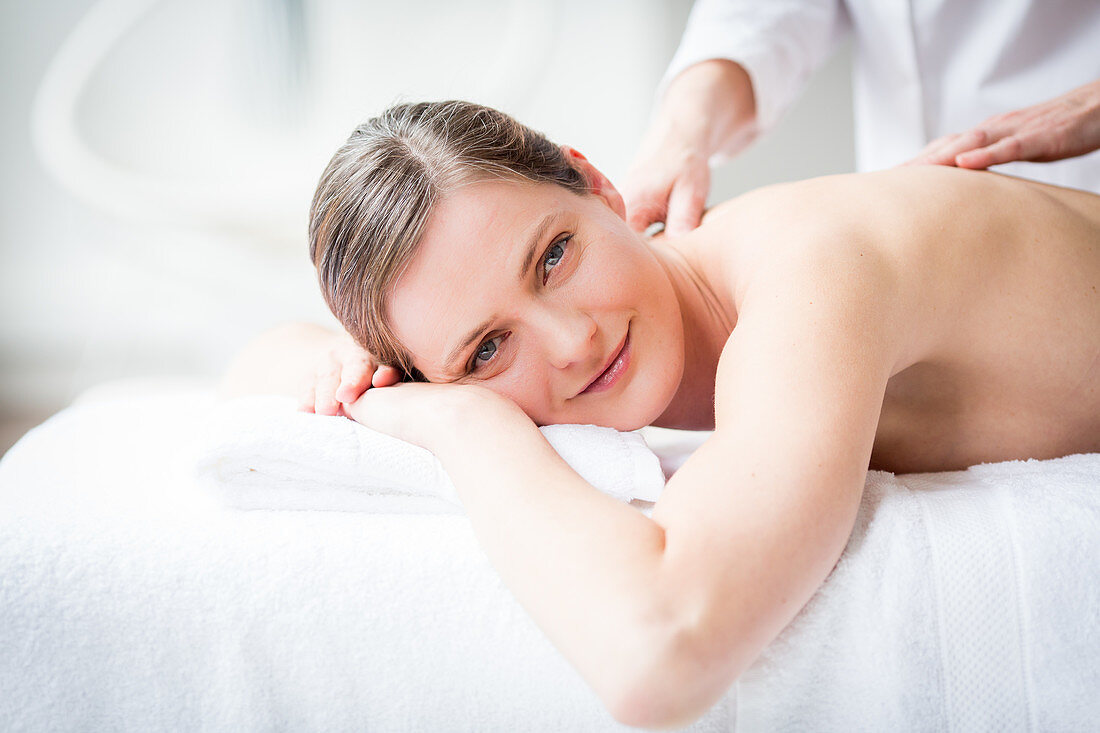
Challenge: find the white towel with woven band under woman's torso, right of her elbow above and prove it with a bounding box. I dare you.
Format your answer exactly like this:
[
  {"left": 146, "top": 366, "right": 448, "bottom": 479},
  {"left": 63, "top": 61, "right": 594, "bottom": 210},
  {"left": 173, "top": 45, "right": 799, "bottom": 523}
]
[{"left": 737, "top": 453, "right": 1100, "bottom": 732}]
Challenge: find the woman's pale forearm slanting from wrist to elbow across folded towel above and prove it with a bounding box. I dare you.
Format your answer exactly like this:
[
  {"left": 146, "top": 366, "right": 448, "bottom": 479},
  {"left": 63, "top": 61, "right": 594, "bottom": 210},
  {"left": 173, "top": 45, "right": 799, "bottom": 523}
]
[{"left": 432, "top": 405, "right": 672, "bottom": 707}]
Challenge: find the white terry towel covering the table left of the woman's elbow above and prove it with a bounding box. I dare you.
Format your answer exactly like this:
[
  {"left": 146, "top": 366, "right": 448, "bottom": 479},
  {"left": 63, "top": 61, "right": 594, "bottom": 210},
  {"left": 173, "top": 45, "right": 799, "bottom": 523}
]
[{"left": 0, "top": 384, "right": 733, "bottom": 733}]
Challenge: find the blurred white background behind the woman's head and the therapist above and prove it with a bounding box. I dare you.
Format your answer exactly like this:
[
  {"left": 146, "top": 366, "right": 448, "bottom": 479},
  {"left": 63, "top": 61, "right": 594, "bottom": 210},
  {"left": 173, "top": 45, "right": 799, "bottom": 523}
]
[{"left": 0, "top": 0, "right": 854, "bottom": 452}]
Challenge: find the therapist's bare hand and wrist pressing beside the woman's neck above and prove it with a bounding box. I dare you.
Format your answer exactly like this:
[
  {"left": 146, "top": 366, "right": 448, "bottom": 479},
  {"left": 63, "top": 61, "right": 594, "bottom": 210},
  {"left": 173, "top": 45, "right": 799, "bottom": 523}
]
[{"left": 623, "top": 58, "right": 756, "bottom": 236}]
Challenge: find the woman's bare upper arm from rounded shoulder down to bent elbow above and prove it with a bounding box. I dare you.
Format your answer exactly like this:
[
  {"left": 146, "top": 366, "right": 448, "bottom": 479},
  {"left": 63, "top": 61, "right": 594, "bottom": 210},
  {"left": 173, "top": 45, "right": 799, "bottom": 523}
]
[{"left": 638, "top": 232, "right": 911, "bottom": 726}]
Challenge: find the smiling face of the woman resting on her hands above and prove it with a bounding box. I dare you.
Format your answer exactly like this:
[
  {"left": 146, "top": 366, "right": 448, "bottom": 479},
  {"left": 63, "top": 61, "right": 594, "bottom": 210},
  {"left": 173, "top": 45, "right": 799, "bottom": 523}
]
[{"left": 387, "top": 158, "right": 684, "bottom": 430}]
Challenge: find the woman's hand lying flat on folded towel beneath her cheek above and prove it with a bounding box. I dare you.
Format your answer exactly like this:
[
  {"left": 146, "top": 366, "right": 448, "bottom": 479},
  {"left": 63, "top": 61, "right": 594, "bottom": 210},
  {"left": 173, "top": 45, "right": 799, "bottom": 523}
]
[{"left": 343, "top": 382, "right": 530, "bottom": 452}]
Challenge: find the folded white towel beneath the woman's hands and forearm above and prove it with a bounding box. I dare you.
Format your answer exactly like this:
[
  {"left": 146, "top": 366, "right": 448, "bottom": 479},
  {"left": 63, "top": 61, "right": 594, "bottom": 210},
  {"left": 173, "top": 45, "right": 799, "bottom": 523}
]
[{"left": 196, "top": 395, "right": 664, "bottom": 513}]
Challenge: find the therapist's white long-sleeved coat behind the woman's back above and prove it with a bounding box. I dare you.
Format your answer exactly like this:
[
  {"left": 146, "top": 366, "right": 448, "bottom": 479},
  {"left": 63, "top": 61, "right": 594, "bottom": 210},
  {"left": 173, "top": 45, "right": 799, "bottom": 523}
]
[{"left": 661, "top": 0, "right": 1100, "bottom": 193}]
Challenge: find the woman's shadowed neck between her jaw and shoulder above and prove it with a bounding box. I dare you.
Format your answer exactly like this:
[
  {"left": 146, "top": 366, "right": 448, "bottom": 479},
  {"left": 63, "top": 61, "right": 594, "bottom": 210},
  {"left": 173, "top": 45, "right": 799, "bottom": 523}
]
[{"left": 648, "top": 231, "right": 737, "bottom": 430}]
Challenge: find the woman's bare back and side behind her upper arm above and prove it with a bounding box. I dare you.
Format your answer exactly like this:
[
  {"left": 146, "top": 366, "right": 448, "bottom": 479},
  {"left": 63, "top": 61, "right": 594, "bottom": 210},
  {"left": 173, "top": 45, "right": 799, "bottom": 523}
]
[{"left": 682, "top": 166, "right": 1100, "bottom": 472}]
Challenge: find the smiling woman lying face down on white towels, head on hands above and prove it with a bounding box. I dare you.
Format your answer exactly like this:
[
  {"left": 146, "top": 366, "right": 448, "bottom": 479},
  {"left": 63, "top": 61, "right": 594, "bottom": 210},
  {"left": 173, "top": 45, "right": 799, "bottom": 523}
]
[{"left": 218, "top": 102, "right": 1100, "bottom": 727}]
